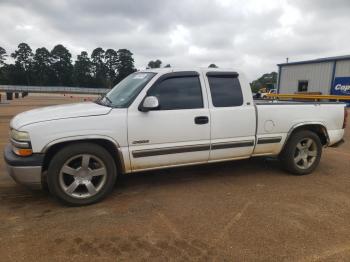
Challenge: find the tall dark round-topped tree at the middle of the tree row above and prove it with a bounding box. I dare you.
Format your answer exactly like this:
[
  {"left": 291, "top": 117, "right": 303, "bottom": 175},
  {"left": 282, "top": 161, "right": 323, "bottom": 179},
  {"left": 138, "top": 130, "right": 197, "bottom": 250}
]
[{"left": 51, "top": 44, "right": 73, "bottom": 86}]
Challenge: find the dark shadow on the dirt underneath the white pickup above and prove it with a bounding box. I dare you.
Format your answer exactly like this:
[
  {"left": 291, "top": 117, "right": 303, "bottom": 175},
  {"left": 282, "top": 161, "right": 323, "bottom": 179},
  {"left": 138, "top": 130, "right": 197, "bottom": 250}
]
[{"left": 0, "top": 158, "right": 287, "bottom": 209}]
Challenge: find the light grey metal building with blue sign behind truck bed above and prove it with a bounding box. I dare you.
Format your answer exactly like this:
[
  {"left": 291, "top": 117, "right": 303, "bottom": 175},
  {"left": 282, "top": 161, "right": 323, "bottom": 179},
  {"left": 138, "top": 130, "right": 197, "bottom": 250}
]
[{"left": 277, "top": 55, "right": 350, "bottom": 95}]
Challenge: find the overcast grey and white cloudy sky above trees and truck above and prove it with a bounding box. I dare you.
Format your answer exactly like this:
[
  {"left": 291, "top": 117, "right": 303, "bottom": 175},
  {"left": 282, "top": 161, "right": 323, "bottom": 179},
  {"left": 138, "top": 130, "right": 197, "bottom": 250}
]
[{"left": 0, "top": 0, "right": 350, "bottom": 80}]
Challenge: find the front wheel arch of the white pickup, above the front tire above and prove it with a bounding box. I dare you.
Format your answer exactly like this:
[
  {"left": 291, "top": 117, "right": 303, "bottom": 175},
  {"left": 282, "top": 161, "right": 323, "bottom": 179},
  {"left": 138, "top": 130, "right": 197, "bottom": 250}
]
[{"left": 42, "top": 137, "right": 125, "bottom": 176}]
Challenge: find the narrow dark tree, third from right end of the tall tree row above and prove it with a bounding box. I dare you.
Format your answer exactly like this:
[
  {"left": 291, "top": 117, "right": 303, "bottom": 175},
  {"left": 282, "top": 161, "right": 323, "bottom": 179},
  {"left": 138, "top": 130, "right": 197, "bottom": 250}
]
[{"left": 91, "top": 47, "right": 107, "bottom": 88}]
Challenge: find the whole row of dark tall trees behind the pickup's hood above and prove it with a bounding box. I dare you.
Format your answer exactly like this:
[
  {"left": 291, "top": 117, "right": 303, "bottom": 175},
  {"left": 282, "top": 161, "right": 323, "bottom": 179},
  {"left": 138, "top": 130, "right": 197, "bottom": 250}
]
[{"left": 0, "top": 43, "right": 136, "bottom": 88}]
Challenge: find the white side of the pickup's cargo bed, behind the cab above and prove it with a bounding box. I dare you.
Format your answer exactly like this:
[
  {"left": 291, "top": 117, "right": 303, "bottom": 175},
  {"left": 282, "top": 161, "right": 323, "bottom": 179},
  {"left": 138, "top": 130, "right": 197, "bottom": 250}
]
[{"left": 254, "top": 100, "right": 345, "bottom": 157}]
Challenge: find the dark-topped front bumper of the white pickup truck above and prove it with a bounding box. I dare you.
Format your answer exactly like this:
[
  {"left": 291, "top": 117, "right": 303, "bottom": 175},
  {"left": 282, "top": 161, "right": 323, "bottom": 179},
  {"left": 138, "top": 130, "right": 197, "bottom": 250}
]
[{"left": 4, "top": 145, "right": 44, "bottom": 189}]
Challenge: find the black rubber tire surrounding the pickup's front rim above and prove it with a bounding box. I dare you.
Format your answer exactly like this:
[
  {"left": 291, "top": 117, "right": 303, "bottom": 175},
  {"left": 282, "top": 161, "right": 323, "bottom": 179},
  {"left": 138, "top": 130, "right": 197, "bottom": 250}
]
[{"left": 47, "top": 143, "right": 117, "bottom": 206}]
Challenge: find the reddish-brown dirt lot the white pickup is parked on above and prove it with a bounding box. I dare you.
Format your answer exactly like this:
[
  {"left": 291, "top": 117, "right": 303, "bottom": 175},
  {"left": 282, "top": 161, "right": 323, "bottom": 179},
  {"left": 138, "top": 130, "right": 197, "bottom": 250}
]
[{"left": 0, "top": 96, "right": 350, "bottom": 261}]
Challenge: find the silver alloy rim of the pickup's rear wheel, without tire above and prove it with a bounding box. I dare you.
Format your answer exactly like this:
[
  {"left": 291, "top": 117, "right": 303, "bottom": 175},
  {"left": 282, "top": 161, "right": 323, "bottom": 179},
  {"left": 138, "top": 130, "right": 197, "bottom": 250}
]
[{"left": 294, "top": 138, "right": 317, "bottom": 169}]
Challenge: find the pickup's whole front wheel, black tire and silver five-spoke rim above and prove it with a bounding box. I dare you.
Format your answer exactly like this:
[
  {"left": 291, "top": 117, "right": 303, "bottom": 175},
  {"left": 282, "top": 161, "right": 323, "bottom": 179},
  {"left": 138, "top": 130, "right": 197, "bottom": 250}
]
[{"left": 47, "top": 143, "right": 117, "bottom": 206}]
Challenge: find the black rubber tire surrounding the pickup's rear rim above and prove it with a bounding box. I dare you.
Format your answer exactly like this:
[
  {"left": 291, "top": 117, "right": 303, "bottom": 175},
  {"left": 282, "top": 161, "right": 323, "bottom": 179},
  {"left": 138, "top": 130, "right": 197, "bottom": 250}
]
[{"left": 280, "top": 130, "right": 322, "bottom": 176}]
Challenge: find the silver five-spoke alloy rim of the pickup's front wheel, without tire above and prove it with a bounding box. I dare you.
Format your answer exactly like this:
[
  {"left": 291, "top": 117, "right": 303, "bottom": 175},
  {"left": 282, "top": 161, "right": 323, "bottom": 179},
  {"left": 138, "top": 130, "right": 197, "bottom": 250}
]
[{"left": 59, "top": 154, "right": 107, "bottom": 198}]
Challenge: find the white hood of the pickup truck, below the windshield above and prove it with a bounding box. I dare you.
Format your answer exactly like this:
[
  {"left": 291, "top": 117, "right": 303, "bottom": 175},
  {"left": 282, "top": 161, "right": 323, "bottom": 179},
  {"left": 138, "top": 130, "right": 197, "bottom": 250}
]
[{"left": 10, "top": 102, "right": 112, "bottom": 129}]
